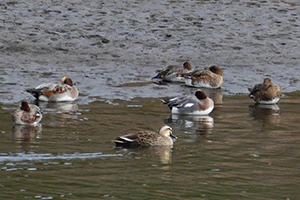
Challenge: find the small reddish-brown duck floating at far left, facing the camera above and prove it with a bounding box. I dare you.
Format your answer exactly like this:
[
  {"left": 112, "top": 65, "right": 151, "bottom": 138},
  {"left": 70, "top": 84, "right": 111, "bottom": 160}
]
[{"left": 13, "top": 100, "right": 43, "bottom": 125}]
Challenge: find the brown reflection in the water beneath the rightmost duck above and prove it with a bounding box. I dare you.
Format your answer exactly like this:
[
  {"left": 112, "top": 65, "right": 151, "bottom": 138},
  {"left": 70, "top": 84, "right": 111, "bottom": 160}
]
[{"left": 249, "top": 104, "right": 280, "bottom": 123}]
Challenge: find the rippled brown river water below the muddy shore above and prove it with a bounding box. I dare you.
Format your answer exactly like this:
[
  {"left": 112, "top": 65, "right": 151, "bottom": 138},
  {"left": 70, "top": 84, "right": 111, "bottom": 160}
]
[{"left": 0, "top": 92, "right": 300, "bottom": 199}]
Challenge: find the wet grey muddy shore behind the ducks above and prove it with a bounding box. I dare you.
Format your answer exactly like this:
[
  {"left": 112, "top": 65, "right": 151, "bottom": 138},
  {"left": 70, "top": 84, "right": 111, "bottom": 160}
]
[{"left": 0, "top": 0, "right": 300, "bottom": 104}]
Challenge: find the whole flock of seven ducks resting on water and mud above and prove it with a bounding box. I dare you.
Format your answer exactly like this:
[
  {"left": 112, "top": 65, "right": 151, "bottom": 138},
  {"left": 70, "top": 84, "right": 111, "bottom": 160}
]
[{"left": 13, "top": 61, "right": 281, "bottom": 148}]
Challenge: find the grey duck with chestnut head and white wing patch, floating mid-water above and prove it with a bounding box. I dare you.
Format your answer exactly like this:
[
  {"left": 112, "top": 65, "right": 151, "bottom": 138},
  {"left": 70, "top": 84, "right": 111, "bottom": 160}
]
[{"left": 162, "top": 90, "right": 214, "bottom": 115}]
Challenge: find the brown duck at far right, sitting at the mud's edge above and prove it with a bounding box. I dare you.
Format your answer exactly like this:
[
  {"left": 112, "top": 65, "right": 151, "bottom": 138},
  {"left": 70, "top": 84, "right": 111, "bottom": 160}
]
[{"left": 248, "top": 78, "right": 282, "bottom": 104}]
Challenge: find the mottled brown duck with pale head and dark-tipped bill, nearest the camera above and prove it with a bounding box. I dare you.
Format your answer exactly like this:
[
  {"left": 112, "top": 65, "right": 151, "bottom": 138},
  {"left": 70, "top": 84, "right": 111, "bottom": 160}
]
[{"left": 112, "top": 125, "right": 177, "bottom": 148}]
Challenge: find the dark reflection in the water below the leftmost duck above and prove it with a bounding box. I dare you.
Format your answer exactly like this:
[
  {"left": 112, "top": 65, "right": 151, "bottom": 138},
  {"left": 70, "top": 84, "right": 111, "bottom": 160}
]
[{"left": 12, "top": 124, "right": 42, "bottom": 152}]
